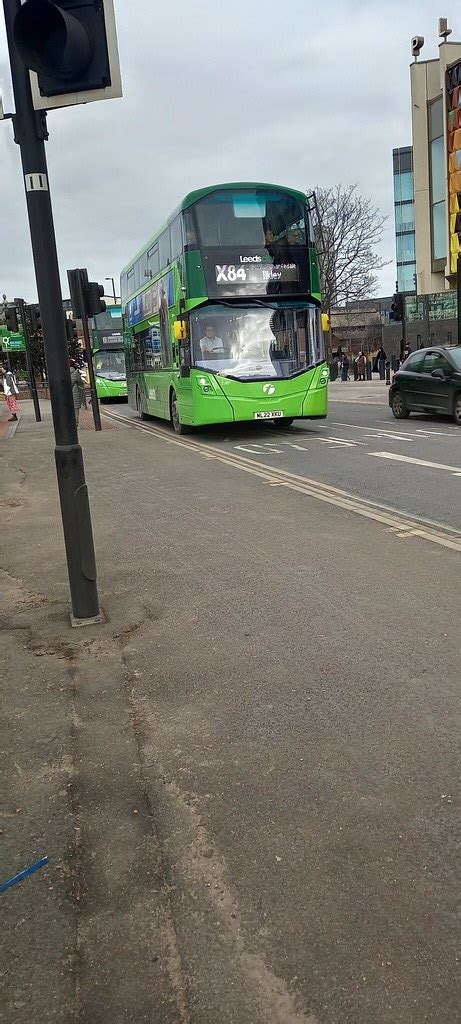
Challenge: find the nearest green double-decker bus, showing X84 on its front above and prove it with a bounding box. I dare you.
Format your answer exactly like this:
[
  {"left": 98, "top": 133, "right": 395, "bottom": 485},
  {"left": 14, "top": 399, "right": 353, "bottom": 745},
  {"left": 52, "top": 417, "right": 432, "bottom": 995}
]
[{"left": 121, "top": 182, "right": 329, "bottom": 433}]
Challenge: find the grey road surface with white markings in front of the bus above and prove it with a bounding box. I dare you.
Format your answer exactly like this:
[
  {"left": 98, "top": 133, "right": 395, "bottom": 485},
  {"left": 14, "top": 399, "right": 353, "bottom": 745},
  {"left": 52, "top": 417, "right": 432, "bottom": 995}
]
[{"left": 103, "top": 381, "right": 461, "bottom": 529}]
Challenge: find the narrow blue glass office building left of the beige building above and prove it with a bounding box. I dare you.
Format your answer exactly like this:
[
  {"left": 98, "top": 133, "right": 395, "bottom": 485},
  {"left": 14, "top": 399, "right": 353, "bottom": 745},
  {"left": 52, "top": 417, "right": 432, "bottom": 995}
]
[{"left": 392, "top": 145, "right": 416, "bottom": 292}]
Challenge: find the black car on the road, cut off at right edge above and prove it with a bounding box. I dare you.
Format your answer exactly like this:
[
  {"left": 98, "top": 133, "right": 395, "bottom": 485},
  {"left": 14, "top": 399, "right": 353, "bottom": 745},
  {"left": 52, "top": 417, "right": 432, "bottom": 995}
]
[{"left": 389, "top": 345, "right": 461, "bottom": 426}]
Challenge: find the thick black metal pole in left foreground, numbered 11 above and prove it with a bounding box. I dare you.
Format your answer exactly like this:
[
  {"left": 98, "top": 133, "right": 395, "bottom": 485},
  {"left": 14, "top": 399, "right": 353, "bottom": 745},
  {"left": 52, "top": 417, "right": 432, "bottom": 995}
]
[{"left": 3, "top": 0, "right": 99, "bottom": 624}]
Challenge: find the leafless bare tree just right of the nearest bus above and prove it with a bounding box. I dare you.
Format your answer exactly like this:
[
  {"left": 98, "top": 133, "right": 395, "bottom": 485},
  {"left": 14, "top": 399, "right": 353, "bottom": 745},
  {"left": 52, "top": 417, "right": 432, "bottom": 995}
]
[{"left": 316, "top": 184, "right": 387, "bottom": 311}]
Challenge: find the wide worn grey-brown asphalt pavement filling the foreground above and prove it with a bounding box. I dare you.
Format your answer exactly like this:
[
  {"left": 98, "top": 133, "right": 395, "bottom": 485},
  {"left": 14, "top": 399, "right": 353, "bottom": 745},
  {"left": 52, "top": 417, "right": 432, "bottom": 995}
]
[{"left": 0, "top": 392, "right": 461, "bottom": 1024}]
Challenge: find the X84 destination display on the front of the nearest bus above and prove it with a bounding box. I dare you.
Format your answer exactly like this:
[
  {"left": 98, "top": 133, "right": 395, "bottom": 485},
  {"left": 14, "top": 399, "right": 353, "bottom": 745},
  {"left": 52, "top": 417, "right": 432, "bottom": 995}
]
[{"left": 203, "top": 246, "right": 309, "bottom": 297}]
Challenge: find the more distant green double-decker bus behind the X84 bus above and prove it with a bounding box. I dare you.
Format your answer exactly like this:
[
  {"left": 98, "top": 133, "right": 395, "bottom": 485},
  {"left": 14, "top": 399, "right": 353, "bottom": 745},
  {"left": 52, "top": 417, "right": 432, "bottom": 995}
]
[{"left": 92, "top": 305, "right": 126, "bottom": 401}]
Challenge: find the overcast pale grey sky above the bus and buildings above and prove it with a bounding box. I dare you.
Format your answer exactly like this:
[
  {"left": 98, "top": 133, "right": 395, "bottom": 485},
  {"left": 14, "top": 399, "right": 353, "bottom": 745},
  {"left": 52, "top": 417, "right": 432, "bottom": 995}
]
[{"left": 0, "top": 0, "right": 461, "bottom": 299}]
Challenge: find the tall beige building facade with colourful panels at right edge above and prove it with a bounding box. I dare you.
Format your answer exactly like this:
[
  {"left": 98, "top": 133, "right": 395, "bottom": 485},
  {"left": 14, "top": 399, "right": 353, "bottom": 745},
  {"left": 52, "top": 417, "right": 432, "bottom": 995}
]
[{"left": 410, "top": 33, "right": 461, "bottom": 294}]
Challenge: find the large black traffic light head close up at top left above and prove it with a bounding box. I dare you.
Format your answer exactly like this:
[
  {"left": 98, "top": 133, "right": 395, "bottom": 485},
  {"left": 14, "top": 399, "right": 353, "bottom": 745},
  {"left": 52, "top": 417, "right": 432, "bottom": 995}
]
[{"left": 13, "top": 0, "right": 122, "bottom": 110}]
